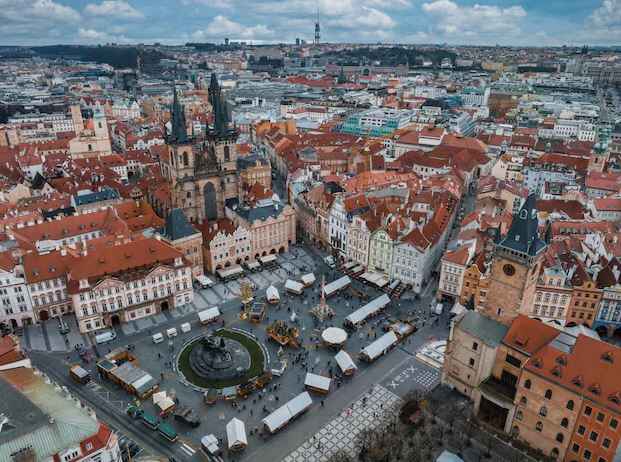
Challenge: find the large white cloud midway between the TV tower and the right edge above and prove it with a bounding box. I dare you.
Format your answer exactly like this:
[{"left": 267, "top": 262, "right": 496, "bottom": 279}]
[{"left": 422, "top": 0, "right": 526, "bottom": 36}]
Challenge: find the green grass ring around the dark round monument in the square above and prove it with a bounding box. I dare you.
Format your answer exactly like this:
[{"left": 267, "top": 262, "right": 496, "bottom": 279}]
[{"left": 178, "top": 329, "right": 265, "bottom": 388}]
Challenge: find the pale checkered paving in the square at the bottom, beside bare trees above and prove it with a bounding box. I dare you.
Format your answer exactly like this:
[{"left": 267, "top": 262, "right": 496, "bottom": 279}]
[{"left": 283, "top": 385, "right": 401, "bottom": 462}]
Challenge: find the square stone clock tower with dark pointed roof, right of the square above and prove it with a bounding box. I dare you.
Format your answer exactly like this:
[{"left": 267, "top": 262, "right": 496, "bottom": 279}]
[{"left": 482, "top": 194, "right": 549, "bottom": 323}]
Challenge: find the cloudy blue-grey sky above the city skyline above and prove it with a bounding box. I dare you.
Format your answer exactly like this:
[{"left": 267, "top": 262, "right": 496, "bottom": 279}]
[{"left": 0, "top": 0, "right": 621, "bottom": 45}]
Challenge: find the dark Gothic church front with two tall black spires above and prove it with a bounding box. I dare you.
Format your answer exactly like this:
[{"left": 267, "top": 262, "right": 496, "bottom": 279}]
[{"left": 162, "top": 74, "right": 239, "bottom": 223}]
